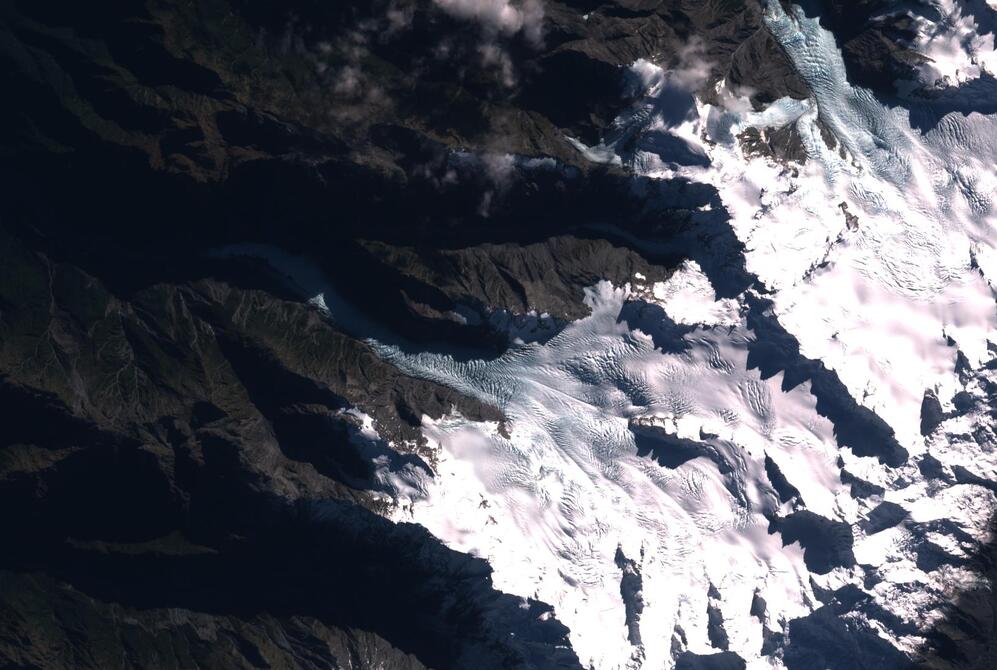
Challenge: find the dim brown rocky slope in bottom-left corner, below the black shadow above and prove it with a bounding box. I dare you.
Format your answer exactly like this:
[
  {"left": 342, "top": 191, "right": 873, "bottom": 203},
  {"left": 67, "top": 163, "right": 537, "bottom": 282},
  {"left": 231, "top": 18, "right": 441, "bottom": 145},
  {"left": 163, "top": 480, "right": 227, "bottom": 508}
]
[{"left": 0, "top": 571, "right": 425, "bottom": 670}]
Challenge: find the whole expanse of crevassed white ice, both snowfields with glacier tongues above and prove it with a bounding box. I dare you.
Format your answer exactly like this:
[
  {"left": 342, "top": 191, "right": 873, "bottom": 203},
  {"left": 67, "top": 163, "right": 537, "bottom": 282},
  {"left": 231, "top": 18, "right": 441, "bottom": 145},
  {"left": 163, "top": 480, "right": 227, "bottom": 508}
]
[{"left": 362, "top": 2, "right": 997, "bottom": 668}]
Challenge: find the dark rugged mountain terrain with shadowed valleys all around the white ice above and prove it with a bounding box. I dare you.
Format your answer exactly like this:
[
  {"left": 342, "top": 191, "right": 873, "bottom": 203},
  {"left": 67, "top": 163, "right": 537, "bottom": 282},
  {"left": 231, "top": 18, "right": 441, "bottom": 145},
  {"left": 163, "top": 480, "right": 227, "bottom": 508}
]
[{"left": 0, "top": 0, "right": 997, "bottom": 668}]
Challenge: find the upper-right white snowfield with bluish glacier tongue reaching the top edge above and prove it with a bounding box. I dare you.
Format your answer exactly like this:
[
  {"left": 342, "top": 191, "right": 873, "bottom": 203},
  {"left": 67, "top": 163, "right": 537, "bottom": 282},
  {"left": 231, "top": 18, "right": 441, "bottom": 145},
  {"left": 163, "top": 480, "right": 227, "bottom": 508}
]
[{"left": 608, "top": 3, "right": 997, "bottom": 462}]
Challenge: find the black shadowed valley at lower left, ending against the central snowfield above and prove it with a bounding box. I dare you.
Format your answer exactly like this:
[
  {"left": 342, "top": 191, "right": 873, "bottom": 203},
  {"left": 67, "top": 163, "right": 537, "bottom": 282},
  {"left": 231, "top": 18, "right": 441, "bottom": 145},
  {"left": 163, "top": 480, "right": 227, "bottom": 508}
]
[{"left": 3, "top": 494, "right": 577, "bottom": 668}]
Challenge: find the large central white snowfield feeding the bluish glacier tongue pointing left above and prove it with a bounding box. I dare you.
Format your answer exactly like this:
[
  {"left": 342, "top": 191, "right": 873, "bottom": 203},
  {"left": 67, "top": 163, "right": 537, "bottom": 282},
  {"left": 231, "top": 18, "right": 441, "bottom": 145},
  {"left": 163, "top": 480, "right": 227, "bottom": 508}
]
[{"left": 378, "top": 283, "right": 836, "bottom": 668}]
